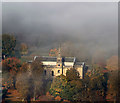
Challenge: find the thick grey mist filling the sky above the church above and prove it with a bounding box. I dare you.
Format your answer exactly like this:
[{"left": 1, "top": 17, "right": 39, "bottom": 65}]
[{"left": 2, "top": 2, "right": 118, "bottom": 63}]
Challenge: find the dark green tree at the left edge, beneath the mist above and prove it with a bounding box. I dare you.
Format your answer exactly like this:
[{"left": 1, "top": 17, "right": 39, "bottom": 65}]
[{"left": 2, "top": 34, "right": 16, "bottom": 59}]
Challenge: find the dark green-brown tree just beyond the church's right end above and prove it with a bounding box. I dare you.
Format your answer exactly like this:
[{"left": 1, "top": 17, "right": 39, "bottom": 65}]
[{"left": 86, "top": 65, "right": 108, "bottom": 101}]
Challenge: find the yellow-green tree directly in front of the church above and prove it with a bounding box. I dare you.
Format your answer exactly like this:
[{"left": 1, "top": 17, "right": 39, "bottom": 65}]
[{"left": 50, "top": 69, "right": 83, "bottom": 101}]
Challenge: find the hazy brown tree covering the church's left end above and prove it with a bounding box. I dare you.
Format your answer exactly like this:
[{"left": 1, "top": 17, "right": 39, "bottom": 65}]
[{"left": 16, "top": 60, "right": 43, "bottom": 101}]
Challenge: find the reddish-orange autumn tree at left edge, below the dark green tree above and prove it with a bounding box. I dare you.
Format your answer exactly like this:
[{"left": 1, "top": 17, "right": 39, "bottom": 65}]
[{"left": 2, "top": 57, "right": 21, "bottom": 88}]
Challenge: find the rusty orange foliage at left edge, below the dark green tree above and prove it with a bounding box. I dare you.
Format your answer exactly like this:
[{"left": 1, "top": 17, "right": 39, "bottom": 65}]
[{"left": 2, "top": 57, "right": 21, "bottom": 87}]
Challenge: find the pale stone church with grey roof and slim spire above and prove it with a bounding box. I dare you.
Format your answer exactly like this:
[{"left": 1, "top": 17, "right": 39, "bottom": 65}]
[{"left": 34, "top": 48, "right": 85, "bottom": 79}]
